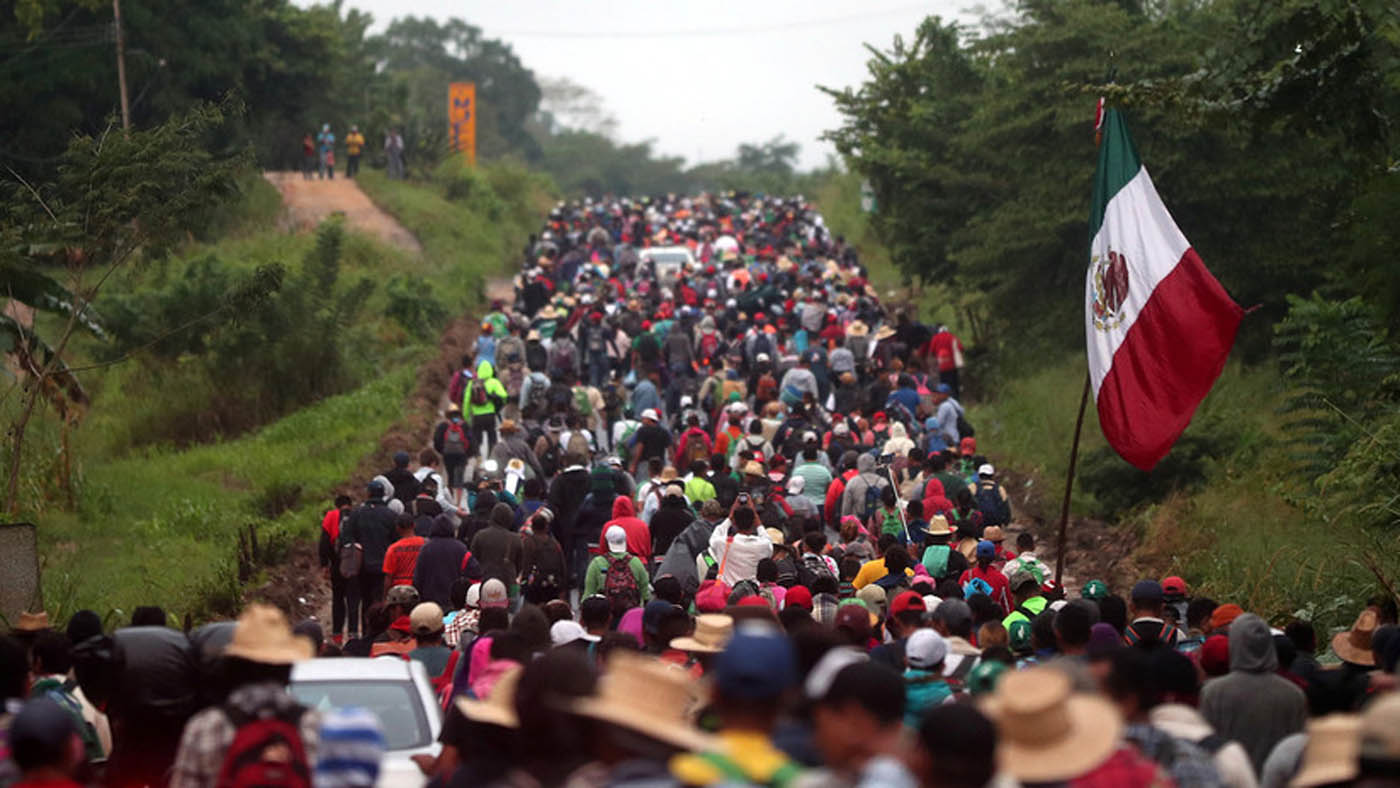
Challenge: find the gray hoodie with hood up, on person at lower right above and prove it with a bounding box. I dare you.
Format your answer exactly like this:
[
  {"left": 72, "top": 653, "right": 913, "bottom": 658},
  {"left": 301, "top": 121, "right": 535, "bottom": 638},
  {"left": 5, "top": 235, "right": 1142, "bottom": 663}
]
[{"left": 1201, "top": 613, "right": 1308, "bottom": 771}]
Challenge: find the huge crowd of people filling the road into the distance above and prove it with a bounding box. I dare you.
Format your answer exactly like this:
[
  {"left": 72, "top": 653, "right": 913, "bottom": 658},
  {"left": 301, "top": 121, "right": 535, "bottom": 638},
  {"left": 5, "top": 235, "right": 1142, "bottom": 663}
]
[{"left": 0, "top": 195, "right": 1400, "bottom": 788}]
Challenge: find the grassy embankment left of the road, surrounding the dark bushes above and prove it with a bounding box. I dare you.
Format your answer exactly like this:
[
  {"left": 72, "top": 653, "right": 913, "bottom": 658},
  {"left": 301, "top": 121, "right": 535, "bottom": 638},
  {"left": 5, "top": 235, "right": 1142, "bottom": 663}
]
[{"left": 25, "top": 164, "right": 549, "bottom": 629}]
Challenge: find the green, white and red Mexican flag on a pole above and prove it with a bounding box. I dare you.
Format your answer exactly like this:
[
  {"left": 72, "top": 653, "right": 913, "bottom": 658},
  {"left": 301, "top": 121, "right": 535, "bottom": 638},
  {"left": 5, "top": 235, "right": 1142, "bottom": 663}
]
[{"left": 1084, "top": 109, "right": 1245, "bottom": 470}]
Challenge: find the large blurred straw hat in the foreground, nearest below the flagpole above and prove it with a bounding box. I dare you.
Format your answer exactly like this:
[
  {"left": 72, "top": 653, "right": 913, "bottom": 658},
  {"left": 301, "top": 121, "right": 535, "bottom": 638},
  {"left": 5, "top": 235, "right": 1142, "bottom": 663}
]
[{"left": 983, "top": 668, "right": 1123, "bottom": 782}]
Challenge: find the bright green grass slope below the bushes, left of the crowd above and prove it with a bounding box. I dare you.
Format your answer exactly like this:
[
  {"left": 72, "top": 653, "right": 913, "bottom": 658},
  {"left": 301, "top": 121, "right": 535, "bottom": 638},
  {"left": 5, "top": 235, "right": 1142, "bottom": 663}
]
[{"left": 38, "top": 367, "right": 413, "bottom": 619}]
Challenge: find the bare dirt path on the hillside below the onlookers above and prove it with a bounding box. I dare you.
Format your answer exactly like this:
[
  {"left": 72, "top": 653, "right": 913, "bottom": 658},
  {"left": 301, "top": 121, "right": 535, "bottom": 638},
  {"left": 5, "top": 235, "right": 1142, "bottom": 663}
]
[{"left": 263, "top": 172, "right": 423, "bottom": 253}]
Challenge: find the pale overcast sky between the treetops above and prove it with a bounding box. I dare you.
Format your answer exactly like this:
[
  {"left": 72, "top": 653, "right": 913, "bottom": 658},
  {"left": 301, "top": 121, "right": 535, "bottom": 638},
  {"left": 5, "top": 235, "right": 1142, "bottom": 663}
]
[{"left": 324, "top": 0, "right": 972, "bottom": 168}]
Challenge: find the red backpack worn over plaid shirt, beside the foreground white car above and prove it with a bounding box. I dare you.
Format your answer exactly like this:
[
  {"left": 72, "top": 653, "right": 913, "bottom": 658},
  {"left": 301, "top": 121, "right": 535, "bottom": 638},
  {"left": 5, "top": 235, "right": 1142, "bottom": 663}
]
[{"left": 217, "top": 705, "right": 311, "bottom": 788}]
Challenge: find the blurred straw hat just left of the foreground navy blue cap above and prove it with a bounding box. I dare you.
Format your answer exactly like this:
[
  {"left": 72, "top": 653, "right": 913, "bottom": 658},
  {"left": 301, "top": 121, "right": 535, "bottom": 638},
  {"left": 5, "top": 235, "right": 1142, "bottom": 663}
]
[{"left": 570, "top": 651, "right": 717, "bottom": 752}]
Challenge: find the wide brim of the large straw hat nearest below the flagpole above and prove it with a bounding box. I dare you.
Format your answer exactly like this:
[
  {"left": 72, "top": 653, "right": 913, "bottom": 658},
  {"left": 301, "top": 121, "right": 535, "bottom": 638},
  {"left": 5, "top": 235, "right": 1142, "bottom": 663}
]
[{"left": 984, "top": 694, "right": 1123, "bottom": 782}]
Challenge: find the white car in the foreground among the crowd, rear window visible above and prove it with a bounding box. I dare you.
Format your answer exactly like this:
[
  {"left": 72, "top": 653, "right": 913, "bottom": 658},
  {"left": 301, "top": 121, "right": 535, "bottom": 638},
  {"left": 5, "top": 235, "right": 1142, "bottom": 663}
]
[{"left": 290, "top": 656, "right": 442, "bottom": 788}]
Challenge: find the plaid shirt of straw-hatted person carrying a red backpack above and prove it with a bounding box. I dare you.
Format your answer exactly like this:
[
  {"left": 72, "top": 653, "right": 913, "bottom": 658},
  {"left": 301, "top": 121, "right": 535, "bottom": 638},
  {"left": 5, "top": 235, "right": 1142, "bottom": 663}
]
[{"left": 169, "top": 683, "right": 321, "bottom": 788}]
